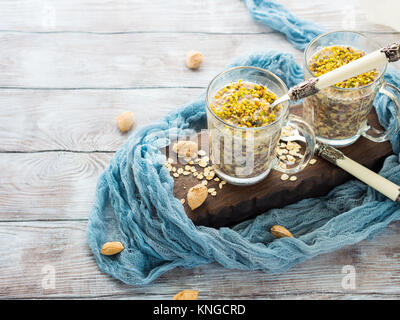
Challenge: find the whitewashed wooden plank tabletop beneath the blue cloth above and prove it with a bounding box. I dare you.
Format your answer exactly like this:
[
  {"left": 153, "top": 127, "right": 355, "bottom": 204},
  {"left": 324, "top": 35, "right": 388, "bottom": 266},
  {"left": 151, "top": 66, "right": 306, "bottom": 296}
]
[{"left": 0, "top": 0, "right": 400, "bottom": 299}]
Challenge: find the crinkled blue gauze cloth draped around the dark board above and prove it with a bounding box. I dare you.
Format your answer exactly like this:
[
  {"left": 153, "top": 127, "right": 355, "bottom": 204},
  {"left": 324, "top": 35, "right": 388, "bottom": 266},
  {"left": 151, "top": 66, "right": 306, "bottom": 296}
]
[{"left": 87, "top": 0, "right": 400, "bottom": 285}]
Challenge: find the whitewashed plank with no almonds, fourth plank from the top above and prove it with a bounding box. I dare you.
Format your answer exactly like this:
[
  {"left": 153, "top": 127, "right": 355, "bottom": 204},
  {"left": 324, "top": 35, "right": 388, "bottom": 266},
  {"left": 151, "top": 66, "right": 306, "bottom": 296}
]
[{"left": 0, "top": 152, "right": 113, "bottom": 220}]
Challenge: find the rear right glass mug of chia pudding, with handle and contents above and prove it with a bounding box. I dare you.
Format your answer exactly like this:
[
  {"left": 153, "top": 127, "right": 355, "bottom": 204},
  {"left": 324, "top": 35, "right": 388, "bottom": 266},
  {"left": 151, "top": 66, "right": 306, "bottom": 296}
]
[{"left": 303, "top": 31, "right": 400, "bottom": 147}]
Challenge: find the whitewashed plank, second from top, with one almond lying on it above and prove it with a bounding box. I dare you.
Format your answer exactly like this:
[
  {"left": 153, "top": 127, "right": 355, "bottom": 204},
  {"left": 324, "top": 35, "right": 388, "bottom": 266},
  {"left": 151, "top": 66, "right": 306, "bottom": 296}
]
[{"left": 0, "top": 33, "right": 399, "bottom": 89}]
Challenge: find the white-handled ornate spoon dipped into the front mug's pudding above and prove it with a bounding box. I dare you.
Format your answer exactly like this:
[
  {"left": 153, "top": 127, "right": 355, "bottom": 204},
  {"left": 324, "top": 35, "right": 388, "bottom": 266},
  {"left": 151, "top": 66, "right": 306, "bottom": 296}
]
[{"left": 271, "top": 43, "right": 400, "bottom": 109}]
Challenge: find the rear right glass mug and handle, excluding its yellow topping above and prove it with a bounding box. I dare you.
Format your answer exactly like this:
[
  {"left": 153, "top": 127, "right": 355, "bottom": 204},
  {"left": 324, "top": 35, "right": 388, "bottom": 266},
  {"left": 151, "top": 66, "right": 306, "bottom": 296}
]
[{"left": 303, "top": 31, "right": 400, "bottom": 147}]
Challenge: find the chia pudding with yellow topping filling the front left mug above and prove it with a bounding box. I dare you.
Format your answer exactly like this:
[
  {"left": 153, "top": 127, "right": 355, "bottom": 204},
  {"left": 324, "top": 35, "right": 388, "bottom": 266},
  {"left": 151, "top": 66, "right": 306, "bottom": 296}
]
[{"left": 208, "top": 80, "right": 281, "bottom": 178}]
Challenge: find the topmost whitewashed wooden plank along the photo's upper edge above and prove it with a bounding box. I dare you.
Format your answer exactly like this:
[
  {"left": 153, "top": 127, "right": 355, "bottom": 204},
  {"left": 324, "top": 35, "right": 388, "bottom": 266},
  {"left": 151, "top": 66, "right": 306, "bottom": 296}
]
[{"left": 0, "top": 0, "right": 391, "bottom": 33}]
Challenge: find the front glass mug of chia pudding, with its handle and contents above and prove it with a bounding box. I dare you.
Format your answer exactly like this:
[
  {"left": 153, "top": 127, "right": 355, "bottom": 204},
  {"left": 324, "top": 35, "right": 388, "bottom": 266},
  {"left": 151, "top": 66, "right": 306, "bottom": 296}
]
[{"left": 206, "top": 66, "right": 315, "bottom": 185}]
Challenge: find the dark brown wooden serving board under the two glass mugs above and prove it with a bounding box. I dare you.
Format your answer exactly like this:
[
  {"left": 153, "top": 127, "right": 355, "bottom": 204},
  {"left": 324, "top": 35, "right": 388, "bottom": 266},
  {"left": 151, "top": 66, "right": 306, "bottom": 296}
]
[{"left": 166, "top": 106, "right": 392, "bottom": 227}]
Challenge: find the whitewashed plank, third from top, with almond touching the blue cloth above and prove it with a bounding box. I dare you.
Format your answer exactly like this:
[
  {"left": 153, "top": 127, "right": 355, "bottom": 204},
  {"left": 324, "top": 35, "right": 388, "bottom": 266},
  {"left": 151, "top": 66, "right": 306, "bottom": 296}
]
[{"left": 0, "top": 88, "right": 204, "bottom": 152}]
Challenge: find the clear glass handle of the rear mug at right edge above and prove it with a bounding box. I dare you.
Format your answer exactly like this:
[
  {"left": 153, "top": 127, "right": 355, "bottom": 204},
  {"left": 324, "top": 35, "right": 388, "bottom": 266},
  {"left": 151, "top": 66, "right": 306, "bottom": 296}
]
[{"left": 362, "top": 82, "right": 400, "bottom": 142}]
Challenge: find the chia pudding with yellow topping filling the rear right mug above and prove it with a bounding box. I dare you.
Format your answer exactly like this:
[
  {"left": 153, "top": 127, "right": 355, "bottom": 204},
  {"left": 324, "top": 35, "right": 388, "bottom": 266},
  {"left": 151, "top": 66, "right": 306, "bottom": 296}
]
[{"left": 303, "top": 46, "right": 378, "bottom": 140}]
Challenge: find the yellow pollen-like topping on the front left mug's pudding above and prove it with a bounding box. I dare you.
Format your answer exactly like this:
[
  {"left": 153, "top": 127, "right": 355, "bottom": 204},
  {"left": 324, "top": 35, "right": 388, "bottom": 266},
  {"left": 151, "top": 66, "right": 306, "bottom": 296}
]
[{"left": 211, "top": 80, "right": 281, "bottom": 128}]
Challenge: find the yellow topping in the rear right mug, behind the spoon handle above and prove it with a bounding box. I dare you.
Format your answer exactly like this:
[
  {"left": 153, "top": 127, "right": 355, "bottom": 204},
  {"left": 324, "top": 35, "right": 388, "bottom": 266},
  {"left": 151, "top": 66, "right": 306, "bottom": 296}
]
[{"left": 309, "top": 46, "right": 378, "bottom": 88}]
